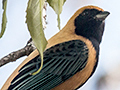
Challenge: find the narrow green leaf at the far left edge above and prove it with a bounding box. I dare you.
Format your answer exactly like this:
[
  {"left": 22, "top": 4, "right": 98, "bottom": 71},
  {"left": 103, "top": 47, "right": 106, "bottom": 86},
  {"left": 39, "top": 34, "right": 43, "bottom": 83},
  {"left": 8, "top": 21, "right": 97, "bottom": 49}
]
[{"left": 0, "top": 0, "right": 7, "bottom": 38}]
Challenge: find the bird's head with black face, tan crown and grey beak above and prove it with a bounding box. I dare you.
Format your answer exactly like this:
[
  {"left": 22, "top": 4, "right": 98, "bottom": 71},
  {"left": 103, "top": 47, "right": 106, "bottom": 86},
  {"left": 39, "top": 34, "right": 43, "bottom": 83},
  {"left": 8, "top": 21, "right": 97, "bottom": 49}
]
[{"left": 66, "top": 6, "right": 109, "bottom": 43}]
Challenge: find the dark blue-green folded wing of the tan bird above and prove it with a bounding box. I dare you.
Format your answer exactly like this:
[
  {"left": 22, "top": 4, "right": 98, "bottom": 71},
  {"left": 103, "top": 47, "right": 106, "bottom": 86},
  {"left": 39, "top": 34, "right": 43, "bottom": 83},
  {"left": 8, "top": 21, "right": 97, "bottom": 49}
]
[{"left": 8, "top": 40, "right": 89, "bottom": 90}]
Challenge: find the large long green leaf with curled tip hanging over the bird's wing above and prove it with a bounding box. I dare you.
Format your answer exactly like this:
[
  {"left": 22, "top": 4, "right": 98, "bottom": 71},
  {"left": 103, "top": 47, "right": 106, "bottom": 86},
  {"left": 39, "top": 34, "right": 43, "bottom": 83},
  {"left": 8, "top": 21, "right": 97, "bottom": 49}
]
[{"left": 26, "top": 0, "right": 47, "bottom": 75}]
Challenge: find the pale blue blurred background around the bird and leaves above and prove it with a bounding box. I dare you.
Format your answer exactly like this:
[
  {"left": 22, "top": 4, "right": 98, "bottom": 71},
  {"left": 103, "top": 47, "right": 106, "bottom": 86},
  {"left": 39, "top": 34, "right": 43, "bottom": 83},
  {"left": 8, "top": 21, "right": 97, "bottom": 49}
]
[{"left": 0, "top": 0, "right": 120, "bottom": 90}]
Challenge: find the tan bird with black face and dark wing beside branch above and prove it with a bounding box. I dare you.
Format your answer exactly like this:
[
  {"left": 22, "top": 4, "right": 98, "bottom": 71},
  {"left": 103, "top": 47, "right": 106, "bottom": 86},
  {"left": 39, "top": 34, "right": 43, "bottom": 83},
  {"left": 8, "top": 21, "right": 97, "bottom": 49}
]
[{"left": 1, "top": 5, "right": 110, "bottom": 90}]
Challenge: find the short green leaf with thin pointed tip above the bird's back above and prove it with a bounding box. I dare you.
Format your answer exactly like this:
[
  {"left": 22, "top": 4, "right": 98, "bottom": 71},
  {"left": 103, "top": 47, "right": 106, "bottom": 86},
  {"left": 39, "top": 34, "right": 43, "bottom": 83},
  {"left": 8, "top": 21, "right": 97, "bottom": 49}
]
[{"left": 47, "top": 0, "right": 66, "bottom": 29}]
